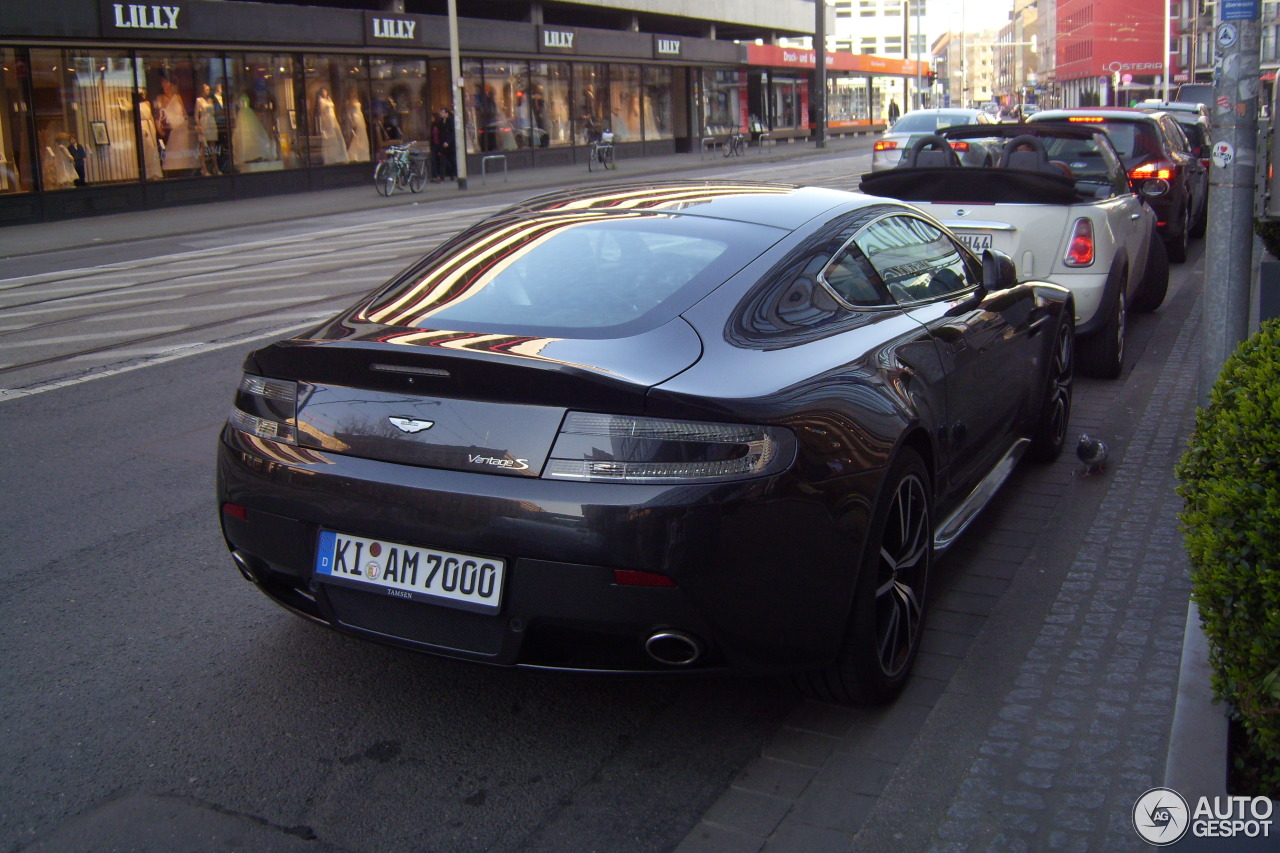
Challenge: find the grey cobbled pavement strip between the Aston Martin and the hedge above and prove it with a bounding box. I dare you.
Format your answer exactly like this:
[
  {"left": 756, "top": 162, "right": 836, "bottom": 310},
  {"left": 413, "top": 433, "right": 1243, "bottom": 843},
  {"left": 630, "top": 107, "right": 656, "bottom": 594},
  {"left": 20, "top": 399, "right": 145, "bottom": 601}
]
[{"left": 677, "top": 242, "right": 1202, "bottom": 853}]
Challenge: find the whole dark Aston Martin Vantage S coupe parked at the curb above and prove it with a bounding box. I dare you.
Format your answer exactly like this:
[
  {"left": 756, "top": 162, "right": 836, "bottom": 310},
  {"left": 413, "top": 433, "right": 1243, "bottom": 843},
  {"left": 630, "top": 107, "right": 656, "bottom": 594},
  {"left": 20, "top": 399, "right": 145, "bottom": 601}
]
[{"left": 218, "top": 182, "right": 1074, "bottom": 703}]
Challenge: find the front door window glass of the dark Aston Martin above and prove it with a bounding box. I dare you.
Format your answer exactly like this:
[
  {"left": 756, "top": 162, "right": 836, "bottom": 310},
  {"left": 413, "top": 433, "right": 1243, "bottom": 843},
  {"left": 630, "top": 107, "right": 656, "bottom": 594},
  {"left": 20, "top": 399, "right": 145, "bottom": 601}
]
[{"left": 855, "top": 215, "right": 977, "bottom": 305}]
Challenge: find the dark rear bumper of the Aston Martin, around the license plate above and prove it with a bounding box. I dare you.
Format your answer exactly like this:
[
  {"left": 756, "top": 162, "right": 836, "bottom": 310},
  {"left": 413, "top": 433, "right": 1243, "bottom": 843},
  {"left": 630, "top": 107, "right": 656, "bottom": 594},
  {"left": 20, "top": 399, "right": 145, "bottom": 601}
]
[{"left": 218, "top": 430, "right": 882, "bottom": 674}]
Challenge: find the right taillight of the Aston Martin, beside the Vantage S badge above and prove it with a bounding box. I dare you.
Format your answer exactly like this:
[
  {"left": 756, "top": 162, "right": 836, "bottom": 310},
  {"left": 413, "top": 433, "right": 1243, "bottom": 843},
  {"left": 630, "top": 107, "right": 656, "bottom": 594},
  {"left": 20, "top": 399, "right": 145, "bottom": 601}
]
[{"left": 543, "top": 411, "right": 795, "bottom": 483}]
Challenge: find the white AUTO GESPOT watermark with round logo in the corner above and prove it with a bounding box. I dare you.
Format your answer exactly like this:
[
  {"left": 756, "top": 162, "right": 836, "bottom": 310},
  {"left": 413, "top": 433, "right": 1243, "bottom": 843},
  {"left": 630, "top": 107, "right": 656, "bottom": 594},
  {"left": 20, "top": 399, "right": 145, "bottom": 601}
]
[{"left": 1133, "top": 788, "right": 1274, "bottom": 847}]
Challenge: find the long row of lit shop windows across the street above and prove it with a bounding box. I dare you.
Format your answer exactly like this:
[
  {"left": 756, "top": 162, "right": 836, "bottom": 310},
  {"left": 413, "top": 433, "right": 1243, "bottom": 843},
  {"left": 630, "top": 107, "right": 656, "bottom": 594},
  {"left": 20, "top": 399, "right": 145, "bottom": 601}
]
[{"left": 0, "top": 31, "right": 911, "bottom": 210}]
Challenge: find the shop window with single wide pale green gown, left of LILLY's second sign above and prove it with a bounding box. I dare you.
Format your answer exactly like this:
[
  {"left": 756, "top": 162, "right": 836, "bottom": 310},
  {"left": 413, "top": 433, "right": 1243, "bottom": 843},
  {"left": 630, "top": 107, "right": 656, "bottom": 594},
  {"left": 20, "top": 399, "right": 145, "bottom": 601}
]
[{"left": 224, "top": 54, "right": 298, "bottom": 173}]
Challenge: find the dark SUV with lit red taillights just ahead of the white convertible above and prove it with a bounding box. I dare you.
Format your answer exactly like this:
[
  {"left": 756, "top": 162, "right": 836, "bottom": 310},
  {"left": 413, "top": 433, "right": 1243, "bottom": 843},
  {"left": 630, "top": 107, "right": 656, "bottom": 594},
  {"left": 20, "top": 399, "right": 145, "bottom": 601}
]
[{"left": 1030, "top": 106, "right": 1208, "bottom": 264}]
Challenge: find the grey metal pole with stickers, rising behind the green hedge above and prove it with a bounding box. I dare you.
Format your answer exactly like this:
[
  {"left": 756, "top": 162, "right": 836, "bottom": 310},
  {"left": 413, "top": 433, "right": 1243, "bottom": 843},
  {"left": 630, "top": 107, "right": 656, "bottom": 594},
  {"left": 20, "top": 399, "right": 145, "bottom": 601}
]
[{"left": 1198, "top": 0, "right": 1261, "bottom": 401}]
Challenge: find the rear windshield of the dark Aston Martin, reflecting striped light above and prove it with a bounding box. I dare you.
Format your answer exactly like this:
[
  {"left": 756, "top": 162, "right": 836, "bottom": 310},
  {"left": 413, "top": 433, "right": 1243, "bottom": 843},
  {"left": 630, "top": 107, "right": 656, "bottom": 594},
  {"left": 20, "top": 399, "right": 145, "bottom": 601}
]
[{"left": 361, "top": 211, "right": 786, "bottom": 337}]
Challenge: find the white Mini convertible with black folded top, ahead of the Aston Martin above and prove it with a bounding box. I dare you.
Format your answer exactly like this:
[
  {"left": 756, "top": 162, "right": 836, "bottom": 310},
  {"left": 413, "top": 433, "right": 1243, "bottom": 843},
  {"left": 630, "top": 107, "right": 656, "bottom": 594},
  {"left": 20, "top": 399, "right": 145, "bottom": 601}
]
[{"left": 861, "top": 122, "right": 1169, "bottom": 378}]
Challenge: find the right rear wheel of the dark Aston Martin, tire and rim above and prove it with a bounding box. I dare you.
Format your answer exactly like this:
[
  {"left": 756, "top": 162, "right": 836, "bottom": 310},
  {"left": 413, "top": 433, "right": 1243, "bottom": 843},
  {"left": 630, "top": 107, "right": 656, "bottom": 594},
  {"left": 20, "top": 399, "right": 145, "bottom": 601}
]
[{"left": 794, "top": 448, "right": 933, "bottom": 706}]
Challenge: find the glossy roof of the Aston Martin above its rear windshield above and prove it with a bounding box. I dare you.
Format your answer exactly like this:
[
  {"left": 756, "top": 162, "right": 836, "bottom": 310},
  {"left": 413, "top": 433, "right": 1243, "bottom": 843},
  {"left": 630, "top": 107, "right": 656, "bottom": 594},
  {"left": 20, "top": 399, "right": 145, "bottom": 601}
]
[{"left": 493, "top": 181, "right": 870, "bottom": 231}]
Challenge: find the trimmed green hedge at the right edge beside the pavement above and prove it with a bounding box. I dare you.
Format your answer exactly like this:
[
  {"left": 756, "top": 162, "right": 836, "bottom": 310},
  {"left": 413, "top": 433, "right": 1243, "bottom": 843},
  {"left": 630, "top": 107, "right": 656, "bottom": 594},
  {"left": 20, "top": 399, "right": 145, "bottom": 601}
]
[{"left": 1178, "top": 320, "right": 1280, "bottom": 797}]
